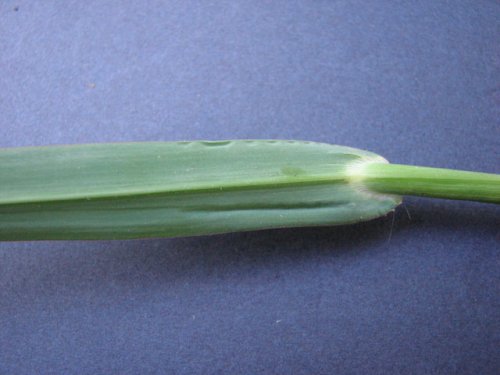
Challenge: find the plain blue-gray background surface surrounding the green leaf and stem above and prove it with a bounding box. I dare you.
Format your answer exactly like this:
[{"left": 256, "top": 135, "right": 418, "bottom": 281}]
[{"left": 0, "top": 0, "right": 500, "bottom": 374}]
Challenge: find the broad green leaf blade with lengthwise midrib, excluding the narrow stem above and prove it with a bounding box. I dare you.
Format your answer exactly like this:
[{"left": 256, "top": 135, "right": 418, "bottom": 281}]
[{"left": 0, "top": 141, "right": 401, "bottom": 240}]
